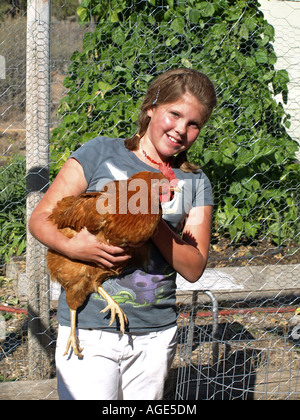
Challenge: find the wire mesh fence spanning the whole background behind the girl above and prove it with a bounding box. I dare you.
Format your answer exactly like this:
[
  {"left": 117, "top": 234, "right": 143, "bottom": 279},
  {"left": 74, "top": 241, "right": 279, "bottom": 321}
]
[{"left": 0, "top": 0, "right": 300, "bottom": 400}]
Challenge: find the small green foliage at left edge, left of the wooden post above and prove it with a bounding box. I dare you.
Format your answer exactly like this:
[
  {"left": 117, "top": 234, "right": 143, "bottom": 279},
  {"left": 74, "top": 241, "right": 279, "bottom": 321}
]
[{"left": 0, "top": 156, "right": 26, "bottom": 265}]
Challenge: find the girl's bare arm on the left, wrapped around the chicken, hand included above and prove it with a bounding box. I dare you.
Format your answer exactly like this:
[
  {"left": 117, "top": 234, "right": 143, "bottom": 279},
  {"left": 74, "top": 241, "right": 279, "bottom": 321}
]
[{"left": 28, "top": 159, "right": 129, "bottom": 267}]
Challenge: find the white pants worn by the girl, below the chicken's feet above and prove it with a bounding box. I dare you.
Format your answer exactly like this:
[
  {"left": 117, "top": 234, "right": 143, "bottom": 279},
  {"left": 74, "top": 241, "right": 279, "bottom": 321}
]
[{"left": 55, "top": 326, "right": 177, "bottom": 400}]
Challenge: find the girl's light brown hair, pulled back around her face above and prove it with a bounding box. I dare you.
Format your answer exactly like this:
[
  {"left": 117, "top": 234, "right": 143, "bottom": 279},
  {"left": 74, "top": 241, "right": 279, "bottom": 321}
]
[{"left": 125, "top": 68, "right": 217, "bottom": 172}]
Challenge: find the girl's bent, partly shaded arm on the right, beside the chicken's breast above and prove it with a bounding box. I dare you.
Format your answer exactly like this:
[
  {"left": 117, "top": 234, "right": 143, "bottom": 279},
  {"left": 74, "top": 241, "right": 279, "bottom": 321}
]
[{"left": 152, "top": 206, "right": 212, "bottom": 283}]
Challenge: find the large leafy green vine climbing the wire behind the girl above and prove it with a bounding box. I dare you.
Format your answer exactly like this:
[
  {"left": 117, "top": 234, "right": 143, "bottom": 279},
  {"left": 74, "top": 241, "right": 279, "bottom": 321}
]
[{"left": 51, "top": 0, "right": 300, "bottom": 243}]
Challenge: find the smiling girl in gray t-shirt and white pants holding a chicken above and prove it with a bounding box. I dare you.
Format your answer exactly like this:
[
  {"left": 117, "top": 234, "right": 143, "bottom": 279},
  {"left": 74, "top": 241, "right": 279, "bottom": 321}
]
[{"left": 29, "top": 68, "right": 216, "bottom": 400}]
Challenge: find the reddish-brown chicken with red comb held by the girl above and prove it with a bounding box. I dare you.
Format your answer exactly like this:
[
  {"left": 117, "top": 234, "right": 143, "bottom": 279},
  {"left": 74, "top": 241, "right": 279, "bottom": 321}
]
[{"left": 47, "top": 169, "right": 178, "bottom": 357}]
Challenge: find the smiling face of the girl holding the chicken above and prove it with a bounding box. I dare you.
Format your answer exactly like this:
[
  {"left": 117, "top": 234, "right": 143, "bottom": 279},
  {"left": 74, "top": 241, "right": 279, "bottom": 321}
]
[{"left": 145, "top": 93, "right": 206, "bottom": 160}]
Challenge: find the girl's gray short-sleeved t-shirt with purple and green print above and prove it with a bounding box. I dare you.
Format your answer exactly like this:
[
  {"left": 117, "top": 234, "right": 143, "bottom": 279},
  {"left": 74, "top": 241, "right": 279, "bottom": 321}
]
[{"left": 58, "top": 137, "right": 213, "bottom": 333}]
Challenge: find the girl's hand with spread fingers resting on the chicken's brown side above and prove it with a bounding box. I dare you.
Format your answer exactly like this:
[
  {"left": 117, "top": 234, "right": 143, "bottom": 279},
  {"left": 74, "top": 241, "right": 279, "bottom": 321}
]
[{"left": 65, "top": 228, "right": 131, "bottom": 268}]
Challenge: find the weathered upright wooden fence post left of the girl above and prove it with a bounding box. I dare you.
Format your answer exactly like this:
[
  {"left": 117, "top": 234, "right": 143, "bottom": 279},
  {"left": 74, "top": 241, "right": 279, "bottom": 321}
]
[{"left": 26, "top": 0, "right": 51, "bottom": 379}]
